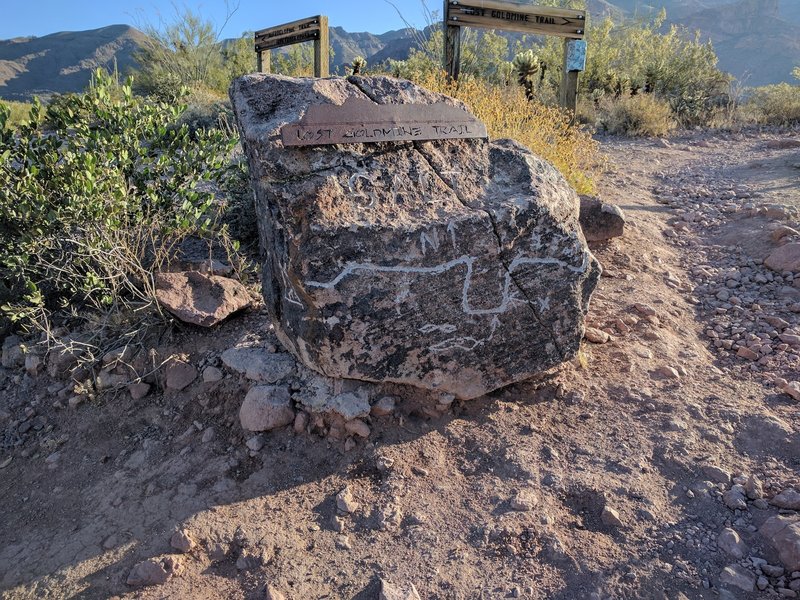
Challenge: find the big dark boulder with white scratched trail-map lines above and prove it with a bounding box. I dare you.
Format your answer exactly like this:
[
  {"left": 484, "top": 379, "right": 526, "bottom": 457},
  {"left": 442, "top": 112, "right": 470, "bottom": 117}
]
[{"left": 230, "top": 74, "right": 600, "bottom": 399}]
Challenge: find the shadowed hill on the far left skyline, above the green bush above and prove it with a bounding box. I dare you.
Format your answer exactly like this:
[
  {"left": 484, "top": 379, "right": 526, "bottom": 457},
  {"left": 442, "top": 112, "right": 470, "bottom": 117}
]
[{"left": 0, "top": 25, "right": 146, "bottom": 100}]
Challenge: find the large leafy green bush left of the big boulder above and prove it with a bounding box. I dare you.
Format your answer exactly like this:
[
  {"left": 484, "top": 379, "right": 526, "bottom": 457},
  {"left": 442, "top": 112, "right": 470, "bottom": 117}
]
[{"left": 0, "top": 70, "right": 244, "bottom": 352}]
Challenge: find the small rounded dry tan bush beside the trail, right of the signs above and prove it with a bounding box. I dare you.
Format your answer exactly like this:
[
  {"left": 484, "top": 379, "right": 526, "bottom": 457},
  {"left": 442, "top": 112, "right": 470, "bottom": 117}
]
[{"left": 599, "top": 94, "right": 675, "bottom": 136}]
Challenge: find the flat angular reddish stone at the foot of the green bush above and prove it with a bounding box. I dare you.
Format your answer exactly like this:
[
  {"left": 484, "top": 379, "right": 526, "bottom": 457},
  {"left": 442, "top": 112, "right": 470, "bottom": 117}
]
[{"left": 155, "top": 271, "right": 251, "bottom": 327}]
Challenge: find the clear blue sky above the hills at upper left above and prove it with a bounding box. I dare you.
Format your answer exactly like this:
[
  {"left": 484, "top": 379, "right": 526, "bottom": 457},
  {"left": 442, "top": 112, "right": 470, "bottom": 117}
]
[{"left": 0, "top": 0, "right": 442, "bottom": 39}]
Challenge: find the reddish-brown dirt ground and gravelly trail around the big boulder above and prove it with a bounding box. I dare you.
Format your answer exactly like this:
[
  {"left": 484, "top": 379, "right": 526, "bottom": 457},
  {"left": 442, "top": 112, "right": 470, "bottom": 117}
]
[{"left": 0, "top": 127, "right": 800, "bottom": 600}]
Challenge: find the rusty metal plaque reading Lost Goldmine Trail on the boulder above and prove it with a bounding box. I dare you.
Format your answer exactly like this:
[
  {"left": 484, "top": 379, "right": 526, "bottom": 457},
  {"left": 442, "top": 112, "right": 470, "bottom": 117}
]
[{"left": 281, "top": 98, "right": 488, "bottom": 146}]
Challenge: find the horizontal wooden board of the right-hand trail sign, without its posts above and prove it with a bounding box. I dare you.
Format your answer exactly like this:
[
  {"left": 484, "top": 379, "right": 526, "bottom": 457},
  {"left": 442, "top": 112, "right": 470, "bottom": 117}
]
[{"left": 445, "top": 0, "right": 586, "bottom": 39}]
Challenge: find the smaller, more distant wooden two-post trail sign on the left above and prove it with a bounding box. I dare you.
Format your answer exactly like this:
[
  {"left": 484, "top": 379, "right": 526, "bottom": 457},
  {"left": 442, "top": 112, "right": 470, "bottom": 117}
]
[{"left": 255, "top": 15, "right": 329, "bottom": 77}]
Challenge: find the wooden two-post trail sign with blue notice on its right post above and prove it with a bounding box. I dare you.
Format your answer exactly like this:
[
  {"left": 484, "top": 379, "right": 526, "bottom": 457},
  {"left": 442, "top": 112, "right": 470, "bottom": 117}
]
[{"left": 444, "top": 0, "right": 586, "bottom": 112}]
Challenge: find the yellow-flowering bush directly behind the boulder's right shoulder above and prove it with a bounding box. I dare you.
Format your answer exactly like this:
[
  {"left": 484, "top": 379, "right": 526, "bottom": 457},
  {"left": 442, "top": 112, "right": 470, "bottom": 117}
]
[{"left": 418, "top": 73, "right": 601, "bottom": 194}]
